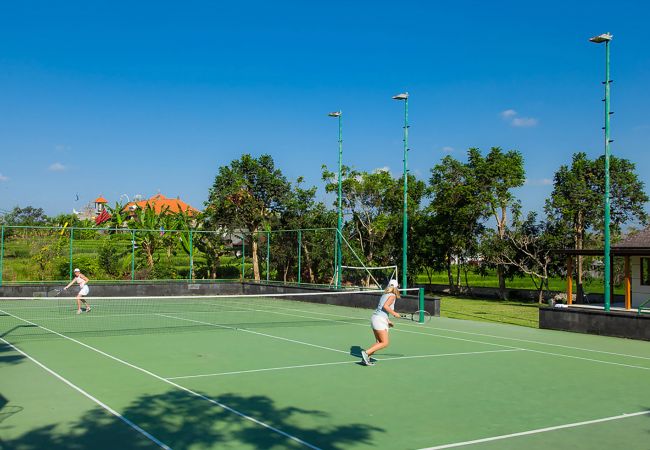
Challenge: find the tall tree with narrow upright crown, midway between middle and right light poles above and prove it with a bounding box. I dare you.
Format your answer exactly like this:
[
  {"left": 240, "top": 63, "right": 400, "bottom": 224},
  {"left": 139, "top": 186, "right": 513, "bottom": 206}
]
[{"left": 468, "top": 147, "right": 526, "bottom": 299}]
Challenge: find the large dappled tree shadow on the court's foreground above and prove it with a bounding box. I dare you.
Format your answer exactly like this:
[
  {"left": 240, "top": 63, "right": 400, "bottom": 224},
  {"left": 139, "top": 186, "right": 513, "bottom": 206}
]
[{"left": 3, "top": 390, "right": 384, "bottom": 450}]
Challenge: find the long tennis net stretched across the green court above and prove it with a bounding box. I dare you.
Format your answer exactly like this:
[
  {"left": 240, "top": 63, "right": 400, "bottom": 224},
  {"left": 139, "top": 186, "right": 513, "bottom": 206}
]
[{"left": 0, "top": 291, "right": 394, "bottom": 339}]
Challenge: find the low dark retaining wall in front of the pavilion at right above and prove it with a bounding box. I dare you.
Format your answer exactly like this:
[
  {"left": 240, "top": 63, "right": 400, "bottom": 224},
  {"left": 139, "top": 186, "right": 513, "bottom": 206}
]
[{"left": 539, "top": 308, "right": 650, "bottom": 341}]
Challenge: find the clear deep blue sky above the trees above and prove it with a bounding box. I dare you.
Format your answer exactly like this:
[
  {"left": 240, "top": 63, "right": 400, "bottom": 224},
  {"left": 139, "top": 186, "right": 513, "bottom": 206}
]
[{"left": 0, "top": 1, "right": 650, "bottom": 218}]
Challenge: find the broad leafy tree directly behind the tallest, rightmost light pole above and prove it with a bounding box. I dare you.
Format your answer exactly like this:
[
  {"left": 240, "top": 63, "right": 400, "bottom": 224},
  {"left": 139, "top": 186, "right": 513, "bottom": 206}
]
[{"left": 544, "top": 152, "right": 648, "bottom": 295}]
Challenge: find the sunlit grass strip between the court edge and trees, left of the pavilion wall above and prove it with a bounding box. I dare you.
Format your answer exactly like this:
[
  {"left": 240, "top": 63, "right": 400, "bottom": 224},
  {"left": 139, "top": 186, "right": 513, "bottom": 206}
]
[{"left": 440, "top": 297, "right": 539, "bottom": 328}]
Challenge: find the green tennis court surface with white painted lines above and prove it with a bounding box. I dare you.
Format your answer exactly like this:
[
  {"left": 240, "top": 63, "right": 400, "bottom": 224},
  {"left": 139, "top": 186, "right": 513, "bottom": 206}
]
[{"left": 0, "top": 297, "right": 650, "bottom": 449}]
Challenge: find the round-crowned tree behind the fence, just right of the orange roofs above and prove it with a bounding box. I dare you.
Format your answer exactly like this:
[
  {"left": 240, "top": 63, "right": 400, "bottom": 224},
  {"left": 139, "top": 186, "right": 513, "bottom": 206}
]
[{"left": 205, "top": 154, "right": 291, "bottom": 280}]
